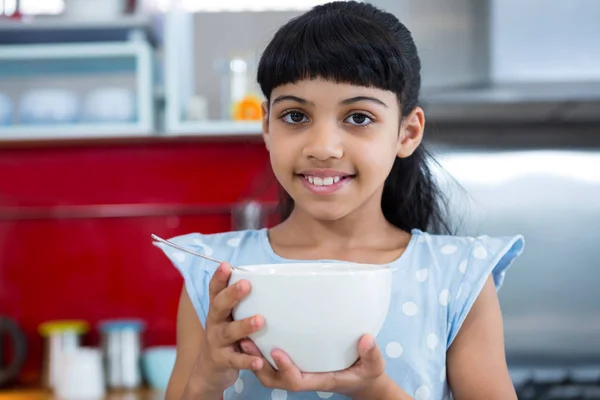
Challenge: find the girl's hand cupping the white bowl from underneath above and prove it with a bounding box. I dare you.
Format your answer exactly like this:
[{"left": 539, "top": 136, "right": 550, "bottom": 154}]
[{"left": 241, "top": 335, "right": 385, "bottom": 397}]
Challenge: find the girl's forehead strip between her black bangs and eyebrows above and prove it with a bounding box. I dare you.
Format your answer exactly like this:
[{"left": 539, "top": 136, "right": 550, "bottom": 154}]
[{"left": 271, "top": 78, "right": 397, "bottom": 104}]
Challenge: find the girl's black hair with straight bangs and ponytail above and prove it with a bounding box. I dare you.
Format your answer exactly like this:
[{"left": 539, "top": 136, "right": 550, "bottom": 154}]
[{"left": 257, "top": 1, "right": 450, "bottom": 233}]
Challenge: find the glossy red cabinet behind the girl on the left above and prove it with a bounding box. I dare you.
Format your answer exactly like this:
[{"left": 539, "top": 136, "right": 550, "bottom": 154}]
[{"left": 0, "top": 138, "right": 276, "bottom": 381}]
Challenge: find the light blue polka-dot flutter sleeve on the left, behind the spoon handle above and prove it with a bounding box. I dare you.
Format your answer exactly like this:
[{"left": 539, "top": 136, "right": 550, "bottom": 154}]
[{"left": 154, "top": 233, "right": 218, "bottom": 328}]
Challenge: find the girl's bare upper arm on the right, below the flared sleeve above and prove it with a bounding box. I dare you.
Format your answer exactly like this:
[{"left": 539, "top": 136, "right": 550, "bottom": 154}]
[{"left": 447, "top": 277, "right": 517, "bottom": 400}]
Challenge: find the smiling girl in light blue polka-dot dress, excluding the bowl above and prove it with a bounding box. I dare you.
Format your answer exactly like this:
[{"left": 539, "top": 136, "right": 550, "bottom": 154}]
[{"left": 162, "top": 1, "right": 523, "bottom": 400}]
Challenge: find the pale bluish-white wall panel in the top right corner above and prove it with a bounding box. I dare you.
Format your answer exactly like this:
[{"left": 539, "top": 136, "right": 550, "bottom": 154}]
[{"left": 491, "top": 0, "right": 600, "bottom": 81}]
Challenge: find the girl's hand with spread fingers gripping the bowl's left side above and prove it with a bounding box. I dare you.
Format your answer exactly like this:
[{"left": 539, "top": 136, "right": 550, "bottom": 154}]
[{"left": 195, "top": 263, "right": 266, "bottom": 392}]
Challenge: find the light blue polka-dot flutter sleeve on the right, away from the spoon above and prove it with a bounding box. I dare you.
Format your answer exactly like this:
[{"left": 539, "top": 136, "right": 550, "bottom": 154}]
[{"left": 447, "top": 235, "right": 524, "bottom": 348}]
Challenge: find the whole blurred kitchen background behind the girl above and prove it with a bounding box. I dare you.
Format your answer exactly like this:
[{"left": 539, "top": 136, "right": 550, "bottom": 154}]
[{"left": 0, "top": 0, "right": 600, "bottom": 399}]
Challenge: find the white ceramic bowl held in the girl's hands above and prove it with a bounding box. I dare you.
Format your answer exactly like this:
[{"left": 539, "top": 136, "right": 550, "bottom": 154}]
[{"left": 230, "top": 263, "right": 392, "bottom": 372}]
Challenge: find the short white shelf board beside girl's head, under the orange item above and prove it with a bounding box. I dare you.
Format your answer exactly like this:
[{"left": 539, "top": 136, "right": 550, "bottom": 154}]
[{"left": 166, "top": 121, "right": 262, "bottom": 137}]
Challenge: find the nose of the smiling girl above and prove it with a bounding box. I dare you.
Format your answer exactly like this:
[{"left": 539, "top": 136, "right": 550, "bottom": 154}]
[{"left": 303, "top": 123, "right": 344, "bottom": 161}]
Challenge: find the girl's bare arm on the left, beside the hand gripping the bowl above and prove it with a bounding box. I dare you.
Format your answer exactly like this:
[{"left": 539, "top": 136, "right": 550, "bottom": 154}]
[{"left": 165, "top": 286, "right": 221, "bottom": 400}]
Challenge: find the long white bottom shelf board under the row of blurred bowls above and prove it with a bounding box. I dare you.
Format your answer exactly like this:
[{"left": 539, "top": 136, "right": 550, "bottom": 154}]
[{"left": 0, "top": 123, "right": 153, "bottom": 143}]
